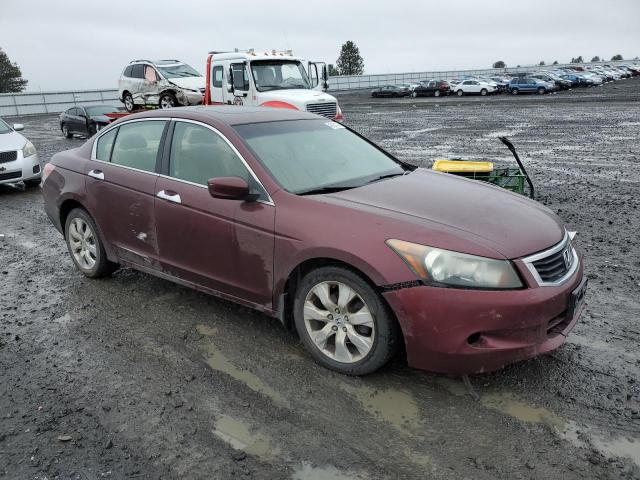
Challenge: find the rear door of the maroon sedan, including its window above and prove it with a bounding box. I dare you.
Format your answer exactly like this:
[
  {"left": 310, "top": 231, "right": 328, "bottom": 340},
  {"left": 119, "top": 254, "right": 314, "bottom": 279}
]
[{"left": 86, "top": 119, "right": 168, "bottom": 268}]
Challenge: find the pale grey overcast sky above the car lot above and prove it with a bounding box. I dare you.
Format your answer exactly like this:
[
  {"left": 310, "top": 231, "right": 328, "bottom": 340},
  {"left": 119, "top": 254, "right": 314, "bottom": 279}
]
[{"left": 0, "top": 0, "right": 640, "bottom": 90}]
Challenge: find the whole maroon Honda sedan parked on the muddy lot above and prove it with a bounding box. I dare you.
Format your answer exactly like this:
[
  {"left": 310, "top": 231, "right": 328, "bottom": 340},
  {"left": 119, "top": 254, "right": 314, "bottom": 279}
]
[{"left": 42, "top": 107, "right": 586, "bottom": 375}]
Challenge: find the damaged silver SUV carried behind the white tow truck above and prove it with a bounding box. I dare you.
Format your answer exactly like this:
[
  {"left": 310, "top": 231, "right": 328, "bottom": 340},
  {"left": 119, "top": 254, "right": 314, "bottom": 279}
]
[{"left": 118, "top": 60, "right": 205, "bottom": 112}]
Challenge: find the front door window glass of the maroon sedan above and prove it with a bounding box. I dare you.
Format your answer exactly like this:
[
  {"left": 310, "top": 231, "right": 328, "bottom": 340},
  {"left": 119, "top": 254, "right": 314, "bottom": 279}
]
[{"left": 169, "top": 122, "right": 250, "bottom": 185}]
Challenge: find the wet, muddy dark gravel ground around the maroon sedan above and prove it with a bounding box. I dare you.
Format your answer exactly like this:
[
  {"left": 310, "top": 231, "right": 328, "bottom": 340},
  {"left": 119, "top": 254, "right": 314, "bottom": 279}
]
[{"left": 0, "top": 79, "right": 640, "bottom": 480}]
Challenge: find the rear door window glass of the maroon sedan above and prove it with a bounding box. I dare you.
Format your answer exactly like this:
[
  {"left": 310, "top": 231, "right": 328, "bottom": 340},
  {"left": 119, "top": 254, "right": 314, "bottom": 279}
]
[{"left": 111, "top": 120, "right": 166, "bottom": 172}]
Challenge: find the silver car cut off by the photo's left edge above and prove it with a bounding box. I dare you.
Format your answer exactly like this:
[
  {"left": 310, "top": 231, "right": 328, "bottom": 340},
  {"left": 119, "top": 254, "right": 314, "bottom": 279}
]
[{"left": 0, "top": 118, "right": 42, "bottom": 187}]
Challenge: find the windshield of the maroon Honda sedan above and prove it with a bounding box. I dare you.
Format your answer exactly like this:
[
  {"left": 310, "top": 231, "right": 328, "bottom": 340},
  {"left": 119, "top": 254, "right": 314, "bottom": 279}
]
[{"left": 234, "top": 120, "right": 405, "bottom": 194}]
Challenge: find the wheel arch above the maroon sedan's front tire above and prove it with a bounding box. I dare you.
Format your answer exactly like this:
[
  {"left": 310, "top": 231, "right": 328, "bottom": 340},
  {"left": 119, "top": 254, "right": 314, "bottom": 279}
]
[{"left": 278, "top": 258, "right": 404, "bottom": 336}]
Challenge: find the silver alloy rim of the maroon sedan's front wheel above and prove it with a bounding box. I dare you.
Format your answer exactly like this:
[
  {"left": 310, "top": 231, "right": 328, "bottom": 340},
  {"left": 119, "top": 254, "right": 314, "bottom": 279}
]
[{"left": 303, "top": 282, "right": 376, "bottom": 363}]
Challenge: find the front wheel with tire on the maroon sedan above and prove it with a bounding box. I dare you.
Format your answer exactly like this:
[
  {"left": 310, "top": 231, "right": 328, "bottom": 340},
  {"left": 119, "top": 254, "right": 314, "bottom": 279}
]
[{"left": 293, "top": 267, "right": 400, "bottom": 375}]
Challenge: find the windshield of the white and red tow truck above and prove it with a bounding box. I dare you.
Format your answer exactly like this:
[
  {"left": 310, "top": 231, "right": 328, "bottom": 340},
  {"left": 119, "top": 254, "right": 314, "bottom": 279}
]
[{"left": 251, "top": 60, "right": 311, "bottom": 92}]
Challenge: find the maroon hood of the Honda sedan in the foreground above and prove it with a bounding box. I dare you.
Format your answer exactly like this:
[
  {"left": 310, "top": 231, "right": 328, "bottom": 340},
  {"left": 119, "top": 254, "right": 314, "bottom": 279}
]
[{"left": 324, "top": 169, "right": 565, "bottom": 259}]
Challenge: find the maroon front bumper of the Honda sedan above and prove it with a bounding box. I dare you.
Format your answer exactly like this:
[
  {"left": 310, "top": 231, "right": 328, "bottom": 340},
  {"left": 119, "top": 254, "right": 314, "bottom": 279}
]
[{"left": 383, "top": 263, "right": 584, "bottom": 374}]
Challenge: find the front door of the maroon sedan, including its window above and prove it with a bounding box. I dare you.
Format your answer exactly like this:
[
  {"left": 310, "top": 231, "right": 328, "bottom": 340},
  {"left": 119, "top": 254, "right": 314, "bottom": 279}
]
[{"left": 155, "top": 120, "right": 275, "bottom": 308}]
